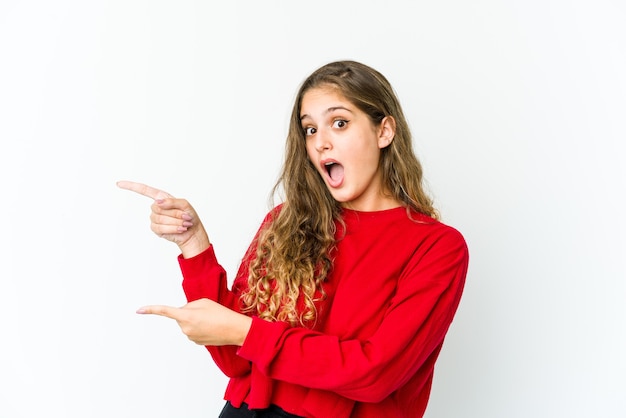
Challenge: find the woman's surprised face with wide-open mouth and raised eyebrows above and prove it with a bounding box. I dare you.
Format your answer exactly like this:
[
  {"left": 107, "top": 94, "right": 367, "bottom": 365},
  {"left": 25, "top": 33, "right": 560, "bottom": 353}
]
[{"left": 300, "top": 86, "right": 400, "bottom": 211}]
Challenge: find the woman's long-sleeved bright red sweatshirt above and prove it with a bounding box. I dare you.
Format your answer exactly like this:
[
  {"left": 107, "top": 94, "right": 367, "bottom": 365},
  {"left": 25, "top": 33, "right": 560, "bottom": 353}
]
[{"left": 179, "top": 208, "right": 469, "bottom": 418}]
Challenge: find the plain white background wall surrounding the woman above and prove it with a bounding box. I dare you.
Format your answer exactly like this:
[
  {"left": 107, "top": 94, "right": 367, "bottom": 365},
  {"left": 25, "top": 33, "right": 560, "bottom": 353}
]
[{"left": 0, "top": 0, "right": 626, "bottom": 418}]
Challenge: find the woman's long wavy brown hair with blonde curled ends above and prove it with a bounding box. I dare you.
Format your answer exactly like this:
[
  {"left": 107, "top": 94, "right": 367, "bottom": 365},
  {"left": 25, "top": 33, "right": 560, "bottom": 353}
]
[{"left": 242, "top": 61, "right": 438, "bottom": 326}]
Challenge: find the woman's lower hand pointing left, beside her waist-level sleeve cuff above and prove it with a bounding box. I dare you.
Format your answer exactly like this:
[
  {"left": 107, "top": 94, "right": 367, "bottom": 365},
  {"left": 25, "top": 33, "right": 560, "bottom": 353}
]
[{"left": 137, "top": 299, "right": 252, "bottom": 346}]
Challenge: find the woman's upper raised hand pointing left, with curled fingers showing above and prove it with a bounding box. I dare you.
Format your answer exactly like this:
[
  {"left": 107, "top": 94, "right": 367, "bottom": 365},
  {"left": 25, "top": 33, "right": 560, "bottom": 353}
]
[{"left": 117, "top": 181, "right": 210, "bottom": 258}]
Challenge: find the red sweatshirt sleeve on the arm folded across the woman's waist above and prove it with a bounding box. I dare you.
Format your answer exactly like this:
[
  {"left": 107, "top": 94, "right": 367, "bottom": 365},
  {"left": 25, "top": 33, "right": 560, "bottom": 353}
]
[{"left": 238, "top": 228, "right": 469, "bottom": 402}]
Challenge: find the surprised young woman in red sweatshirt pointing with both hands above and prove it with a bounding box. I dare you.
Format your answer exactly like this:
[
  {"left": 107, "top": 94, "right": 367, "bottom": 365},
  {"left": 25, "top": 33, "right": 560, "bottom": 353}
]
[{"left": 118, "top": 61, "right": 468, "bottom": 418}]
